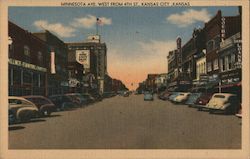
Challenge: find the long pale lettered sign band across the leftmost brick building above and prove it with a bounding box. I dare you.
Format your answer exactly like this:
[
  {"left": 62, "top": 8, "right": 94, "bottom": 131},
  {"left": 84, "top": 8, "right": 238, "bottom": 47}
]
[{"left": 9, "top": 58, "right": 47, "bottom": 72}]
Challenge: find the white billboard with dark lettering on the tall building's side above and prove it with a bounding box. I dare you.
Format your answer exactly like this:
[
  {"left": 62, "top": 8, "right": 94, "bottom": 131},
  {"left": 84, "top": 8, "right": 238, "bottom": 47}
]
[{"left": 76, "top": 50, "right": 90, "bottom": 69}]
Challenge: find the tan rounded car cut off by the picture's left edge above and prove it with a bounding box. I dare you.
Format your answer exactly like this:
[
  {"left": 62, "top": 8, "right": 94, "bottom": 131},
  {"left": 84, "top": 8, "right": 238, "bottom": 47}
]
[{"left": 8, "top": 96, "right": 38, "bottom": 122}]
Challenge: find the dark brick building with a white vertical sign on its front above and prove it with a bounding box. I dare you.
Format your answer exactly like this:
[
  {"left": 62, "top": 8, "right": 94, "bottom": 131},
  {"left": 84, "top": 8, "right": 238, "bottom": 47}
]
[{"left": 33, "top": 30, "right": 69, "bottom": 95}]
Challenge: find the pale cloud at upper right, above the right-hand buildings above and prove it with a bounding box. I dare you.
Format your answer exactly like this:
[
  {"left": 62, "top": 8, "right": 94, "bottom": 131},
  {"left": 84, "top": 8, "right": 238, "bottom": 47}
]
[{"left": 166, "top": 9, "right": 211, "bottom": 27}]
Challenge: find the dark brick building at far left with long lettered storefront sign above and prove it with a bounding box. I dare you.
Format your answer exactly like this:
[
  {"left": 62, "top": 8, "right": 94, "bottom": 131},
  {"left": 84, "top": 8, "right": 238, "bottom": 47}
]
[{"left": 8, "top": 21, "right": 49, "bottom": 96}]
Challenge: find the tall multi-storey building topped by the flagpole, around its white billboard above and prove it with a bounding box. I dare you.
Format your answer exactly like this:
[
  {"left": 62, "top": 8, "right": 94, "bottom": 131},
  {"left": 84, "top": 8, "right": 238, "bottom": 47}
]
[{"left": 67, "top": 35, "right": 107, "bottom": 94}]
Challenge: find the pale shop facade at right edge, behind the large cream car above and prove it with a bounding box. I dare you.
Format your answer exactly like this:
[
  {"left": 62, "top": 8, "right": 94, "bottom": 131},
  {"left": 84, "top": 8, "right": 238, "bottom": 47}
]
[{"left": 218, "top": 32, "right": 242, "bottom": 94}]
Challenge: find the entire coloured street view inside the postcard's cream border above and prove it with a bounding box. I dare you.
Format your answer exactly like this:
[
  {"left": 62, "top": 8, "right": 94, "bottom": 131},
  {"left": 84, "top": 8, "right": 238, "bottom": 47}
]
[{"left": 8, "top": 6, "right": 243, "bottom": 149}]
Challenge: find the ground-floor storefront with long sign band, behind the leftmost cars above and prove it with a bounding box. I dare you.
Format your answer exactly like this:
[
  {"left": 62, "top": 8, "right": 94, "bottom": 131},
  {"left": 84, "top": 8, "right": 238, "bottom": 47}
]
[{"left": 9, "top": 58, "right": 47, "bottom": 96}]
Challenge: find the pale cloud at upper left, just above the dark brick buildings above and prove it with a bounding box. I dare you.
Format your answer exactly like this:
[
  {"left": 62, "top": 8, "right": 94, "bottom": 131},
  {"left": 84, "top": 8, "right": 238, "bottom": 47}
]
[{"left": 33, "top": 20, "right": 76, "bottom": 38}]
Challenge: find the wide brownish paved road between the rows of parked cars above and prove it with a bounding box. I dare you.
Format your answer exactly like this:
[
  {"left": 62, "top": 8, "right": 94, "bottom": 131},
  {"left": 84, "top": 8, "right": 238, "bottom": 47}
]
[{"left": 9, "top": 95, "right": 241, "bottom": 149}]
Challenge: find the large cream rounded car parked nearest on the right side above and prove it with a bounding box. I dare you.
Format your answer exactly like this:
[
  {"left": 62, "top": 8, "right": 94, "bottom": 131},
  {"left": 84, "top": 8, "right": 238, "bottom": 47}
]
[{"left": 206, "top": 93, "right": 240, "bottom": 114}]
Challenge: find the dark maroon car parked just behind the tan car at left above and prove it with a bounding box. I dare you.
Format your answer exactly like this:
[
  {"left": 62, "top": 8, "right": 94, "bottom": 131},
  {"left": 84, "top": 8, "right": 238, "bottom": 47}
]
[{"left": 23, "top": 96, "right": 56, "bottom": 116}]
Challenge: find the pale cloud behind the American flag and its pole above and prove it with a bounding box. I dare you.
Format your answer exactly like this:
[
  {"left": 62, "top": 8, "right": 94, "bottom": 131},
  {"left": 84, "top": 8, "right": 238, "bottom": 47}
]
[{"left": 72, "top": 15, "right": 112, "bottom": 29}]
